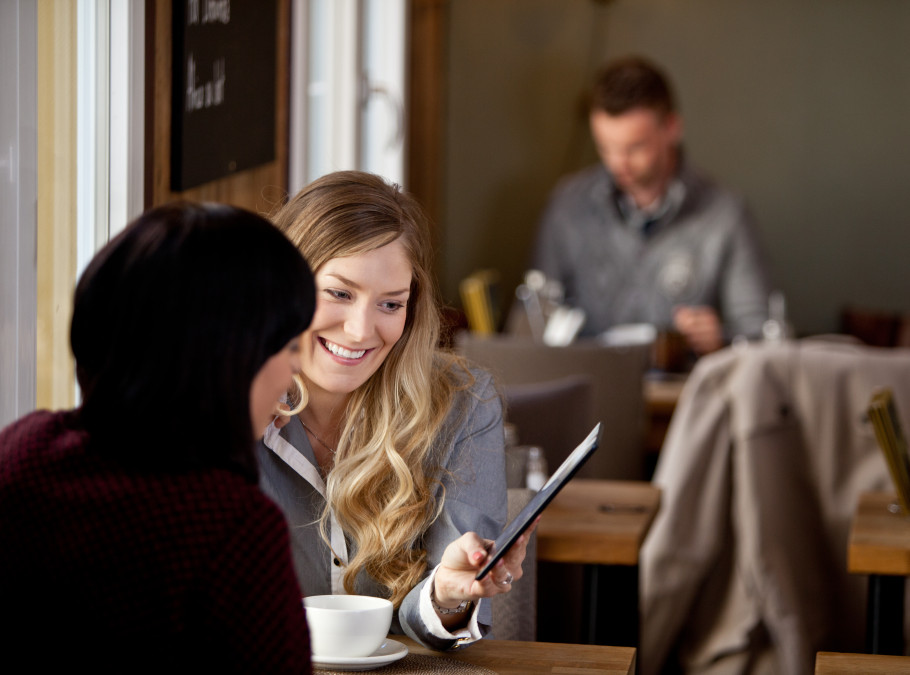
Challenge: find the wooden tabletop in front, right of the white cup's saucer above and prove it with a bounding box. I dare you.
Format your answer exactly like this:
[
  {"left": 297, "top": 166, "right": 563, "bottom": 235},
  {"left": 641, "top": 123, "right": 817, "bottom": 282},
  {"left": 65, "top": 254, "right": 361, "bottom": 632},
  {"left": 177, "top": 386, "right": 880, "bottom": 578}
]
[{"left": 400, "top": 635, "right": 636, "bottom": 675}]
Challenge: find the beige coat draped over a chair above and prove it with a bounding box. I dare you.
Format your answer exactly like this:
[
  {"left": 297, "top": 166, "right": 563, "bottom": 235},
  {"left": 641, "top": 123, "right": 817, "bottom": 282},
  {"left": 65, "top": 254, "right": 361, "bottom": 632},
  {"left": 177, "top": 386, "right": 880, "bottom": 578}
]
[{"left": 640, "top": 340, "right": 910, "bottom": 675}]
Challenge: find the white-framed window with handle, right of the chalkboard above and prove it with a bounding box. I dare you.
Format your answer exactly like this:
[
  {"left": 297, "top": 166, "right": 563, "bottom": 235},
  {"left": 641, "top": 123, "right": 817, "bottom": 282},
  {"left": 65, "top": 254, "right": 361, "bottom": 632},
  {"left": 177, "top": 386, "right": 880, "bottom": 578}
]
[{"left": 289, "top": 0, "right": 407, "bottom": 194}]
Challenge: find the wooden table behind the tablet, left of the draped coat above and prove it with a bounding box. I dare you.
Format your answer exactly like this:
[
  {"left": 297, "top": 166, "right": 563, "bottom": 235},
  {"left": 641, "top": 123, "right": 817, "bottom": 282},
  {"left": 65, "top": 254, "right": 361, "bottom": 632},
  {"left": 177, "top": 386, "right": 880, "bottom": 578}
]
[{"left": 537, "top": 478, "right": 660, "bottom": 646}]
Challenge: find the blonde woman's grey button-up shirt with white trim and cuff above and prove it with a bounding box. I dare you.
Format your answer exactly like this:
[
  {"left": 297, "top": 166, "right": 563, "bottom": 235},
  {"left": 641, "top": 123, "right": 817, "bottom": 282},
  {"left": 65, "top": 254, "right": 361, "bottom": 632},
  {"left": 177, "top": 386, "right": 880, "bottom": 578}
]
[{"left": 257, "top": 370, "right": 508, "bottom": 650}]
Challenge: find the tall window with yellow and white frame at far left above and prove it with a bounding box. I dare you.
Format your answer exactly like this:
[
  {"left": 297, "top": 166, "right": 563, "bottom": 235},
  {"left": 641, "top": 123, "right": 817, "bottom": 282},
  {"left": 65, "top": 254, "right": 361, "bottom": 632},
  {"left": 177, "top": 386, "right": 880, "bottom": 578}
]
[{"left": 0, "top": 0, "right": 145, "bottom": 426}]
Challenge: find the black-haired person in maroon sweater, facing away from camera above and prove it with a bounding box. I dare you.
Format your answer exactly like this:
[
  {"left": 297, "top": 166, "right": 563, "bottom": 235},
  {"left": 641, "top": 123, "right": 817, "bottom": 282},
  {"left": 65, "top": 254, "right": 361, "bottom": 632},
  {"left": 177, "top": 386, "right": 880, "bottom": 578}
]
[{"left": 0, "top": 204, "right": 315, "bottom": 673}]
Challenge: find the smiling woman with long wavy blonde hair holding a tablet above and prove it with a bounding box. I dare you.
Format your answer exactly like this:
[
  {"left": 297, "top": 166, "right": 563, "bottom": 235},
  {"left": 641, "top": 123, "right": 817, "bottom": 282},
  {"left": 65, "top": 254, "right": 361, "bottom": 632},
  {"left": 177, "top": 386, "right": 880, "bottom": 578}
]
[{"left": 258, "top": 171, "right": 525, "bottom": 650}]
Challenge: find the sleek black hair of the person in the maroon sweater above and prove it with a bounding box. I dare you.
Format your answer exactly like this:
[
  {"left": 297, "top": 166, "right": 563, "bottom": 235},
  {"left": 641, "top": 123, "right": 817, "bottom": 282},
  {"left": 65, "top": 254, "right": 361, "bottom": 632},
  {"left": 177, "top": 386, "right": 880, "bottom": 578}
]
[{"left": 70, "top": 204, "right": 315, "bottom": 470}]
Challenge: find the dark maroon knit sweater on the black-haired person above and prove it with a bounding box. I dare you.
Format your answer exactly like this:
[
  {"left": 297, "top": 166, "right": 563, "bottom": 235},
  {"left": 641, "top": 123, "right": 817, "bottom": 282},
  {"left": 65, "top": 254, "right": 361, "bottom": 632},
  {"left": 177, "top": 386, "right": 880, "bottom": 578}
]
[{"left": 0, "top": 411, "right": 311, "bottom": 673}]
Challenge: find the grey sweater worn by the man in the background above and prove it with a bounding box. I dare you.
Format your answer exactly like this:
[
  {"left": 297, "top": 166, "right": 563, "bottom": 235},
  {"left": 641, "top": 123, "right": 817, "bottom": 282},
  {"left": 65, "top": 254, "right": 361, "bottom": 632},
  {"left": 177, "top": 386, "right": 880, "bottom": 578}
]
[{"left": 533, "top": 163, "right": 769, "bottom": 339}]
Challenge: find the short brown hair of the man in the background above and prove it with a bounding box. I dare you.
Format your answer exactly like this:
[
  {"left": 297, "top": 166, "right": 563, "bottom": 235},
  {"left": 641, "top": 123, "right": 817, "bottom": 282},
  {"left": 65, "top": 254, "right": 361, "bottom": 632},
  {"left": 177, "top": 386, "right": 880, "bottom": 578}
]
[{"left": 590, "top": 56, "right": 676, "bottom": 117}]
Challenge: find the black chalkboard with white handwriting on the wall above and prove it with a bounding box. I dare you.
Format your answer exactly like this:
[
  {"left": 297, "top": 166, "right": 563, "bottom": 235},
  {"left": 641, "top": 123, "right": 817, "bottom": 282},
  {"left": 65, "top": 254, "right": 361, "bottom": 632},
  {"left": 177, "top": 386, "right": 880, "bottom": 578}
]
[{"left": 171, "top": 0, "right": 277, "bottom": 192}]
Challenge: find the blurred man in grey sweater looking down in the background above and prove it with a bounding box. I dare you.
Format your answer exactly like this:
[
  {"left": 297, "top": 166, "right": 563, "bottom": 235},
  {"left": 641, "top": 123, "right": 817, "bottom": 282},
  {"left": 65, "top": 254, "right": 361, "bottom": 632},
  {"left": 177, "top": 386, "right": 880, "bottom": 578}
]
[{"left": 534, "top": 57, "right": 769, "bottom": 354}]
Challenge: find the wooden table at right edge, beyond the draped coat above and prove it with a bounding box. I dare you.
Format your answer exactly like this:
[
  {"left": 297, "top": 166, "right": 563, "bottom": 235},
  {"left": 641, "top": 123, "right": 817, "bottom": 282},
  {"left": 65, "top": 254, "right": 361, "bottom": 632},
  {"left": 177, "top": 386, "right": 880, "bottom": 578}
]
[{"left": 847, "top": 492, "right": 910, "bottom": 654}]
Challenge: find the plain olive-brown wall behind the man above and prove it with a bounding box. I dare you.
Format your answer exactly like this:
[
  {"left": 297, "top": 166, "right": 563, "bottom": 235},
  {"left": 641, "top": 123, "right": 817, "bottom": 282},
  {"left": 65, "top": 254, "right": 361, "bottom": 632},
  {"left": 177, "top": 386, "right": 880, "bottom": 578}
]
[{"left": 440, "top": 0, "right": 910, "bottom": 334}]
